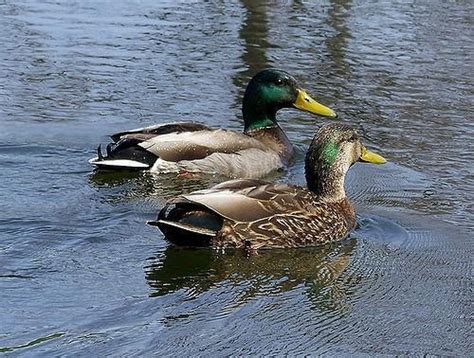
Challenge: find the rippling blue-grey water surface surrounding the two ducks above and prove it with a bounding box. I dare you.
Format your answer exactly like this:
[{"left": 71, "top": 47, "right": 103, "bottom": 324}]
[{"left": 0, "top": 0, "right": 474, "bottom": 356}]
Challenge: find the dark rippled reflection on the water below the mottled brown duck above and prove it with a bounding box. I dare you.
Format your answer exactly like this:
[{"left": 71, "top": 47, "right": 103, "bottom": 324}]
[{"left": 145, "top": 239, "right": 356, "bottom": 309}]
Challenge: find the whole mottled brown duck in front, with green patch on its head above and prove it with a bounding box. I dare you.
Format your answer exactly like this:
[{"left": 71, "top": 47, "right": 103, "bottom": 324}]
[{"left": 148, "top": 123, "right": 386, "bottom": 251}]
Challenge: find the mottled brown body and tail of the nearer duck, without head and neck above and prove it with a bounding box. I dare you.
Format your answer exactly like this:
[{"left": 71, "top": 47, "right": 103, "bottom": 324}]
[{"left": 151, "top": 179, "right": 355, "bottom": 249}]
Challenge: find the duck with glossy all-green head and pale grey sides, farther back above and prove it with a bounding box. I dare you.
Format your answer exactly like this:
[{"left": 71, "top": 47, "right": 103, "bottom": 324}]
[{"left": 89, "top": 69, "right": 337, "bottom": 178}]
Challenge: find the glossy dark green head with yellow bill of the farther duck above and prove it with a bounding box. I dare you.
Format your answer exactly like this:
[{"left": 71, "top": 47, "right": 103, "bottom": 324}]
[{"left": 242, "top": 69, "right": 336, "bottom": 131}]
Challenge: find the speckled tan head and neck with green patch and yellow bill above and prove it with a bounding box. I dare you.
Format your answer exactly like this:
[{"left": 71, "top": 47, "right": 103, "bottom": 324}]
[{"left": 305, "top": 123, "right": 386, "bottom": 201}]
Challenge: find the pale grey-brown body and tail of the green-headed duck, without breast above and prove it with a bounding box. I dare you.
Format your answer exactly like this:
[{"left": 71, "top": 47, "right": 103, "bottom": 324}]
[{"left": 89, "top": 123, "right": 274, "bottom": 175}]
